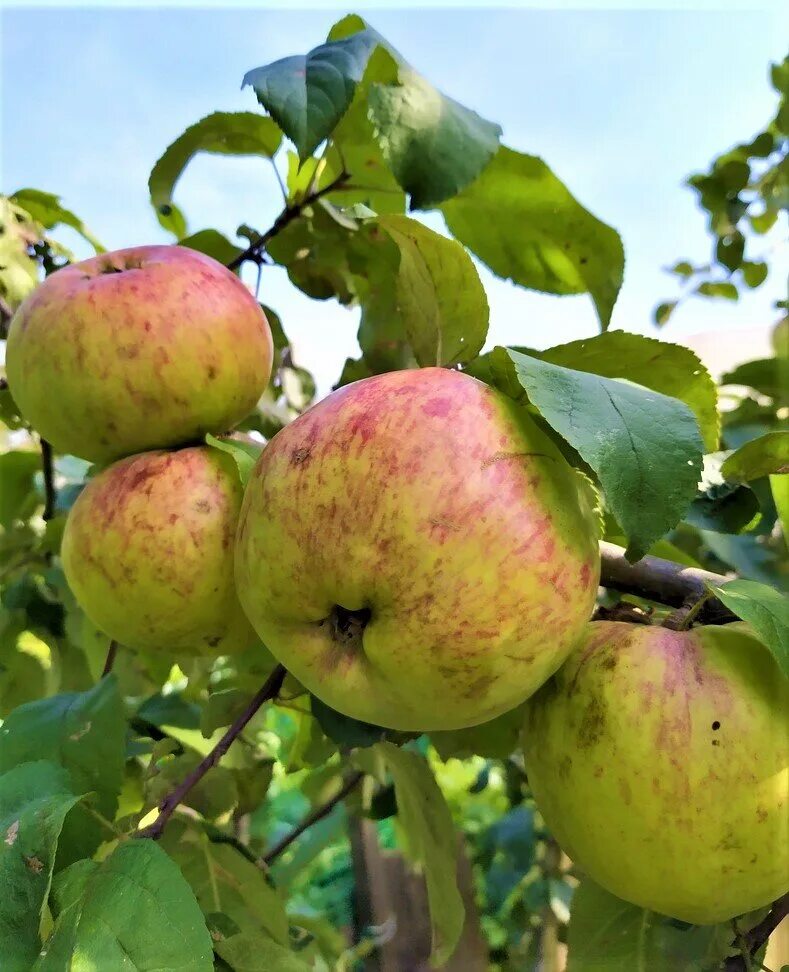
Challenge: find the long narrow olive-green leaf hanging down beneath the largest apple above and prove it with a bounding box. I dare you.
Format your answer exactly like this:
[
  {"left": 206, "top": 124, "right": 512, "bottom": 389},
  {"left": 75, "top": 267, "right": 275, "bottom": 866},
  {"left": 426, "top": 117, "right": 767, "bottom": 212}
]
[{"left": 377, "top": 742, "right": 465, "bottom": 965}]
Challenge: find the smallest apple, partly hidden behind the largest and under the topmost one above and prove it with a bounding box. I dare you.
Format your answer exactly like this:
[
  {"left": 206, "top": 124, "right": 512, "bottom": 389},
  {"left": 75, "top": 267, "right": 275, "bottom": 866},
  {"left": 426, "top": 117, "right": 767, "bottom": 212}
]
[{"left": 61, "top": 446, "right": 257, "bottom": 655}]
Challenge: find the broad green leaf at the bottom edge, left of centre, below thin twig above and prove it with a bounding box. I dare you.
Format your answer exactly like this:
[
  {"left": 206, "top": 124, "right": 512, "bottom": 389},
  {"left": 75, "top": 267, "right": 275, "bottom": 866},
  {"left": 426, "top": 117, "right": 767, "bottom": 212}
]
[{"left": 34, "top": 840, "right": 214, "bottom": 972}]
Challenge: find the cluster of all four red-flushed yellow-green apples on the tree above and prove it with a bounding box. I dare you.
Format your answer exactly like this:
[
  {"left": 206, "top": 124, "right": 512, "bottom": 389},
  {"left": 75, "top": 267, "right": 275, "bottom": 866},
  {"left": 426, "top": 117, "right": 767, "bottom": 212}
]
[{"left": 7, "top": 247, "right": 789, "bottom": 923}]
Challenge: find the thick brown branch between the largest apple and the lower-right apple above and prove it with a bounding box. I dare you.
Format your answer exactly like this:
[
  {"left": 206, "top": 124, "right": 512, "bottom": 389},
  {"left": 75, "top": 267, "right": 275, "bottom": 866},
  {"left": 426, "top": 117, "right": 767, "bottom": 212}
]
[{"left": 600, "top": 541, "right": 738, "bottom": 624}]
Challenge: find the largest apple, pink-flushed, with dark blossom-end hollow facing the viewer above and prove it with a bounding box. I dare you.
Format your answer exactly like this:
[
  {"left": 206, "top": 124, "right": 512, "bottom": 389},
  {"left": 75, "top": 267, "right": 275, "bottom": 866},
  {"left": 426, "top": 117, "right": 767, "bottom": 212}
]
[{"left": 236, "top": 368, "right": 600, "bottom": 731}]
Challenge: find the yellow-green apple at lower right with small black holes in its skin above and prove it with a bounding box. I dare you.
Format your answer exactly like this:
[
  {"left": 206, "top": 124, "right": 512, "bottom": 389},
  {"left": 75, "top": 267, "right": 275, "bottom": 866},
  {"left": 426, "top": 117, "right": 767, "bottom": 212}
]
[{"left": 523, "top": 621, "right": 789, "bottom": 925}]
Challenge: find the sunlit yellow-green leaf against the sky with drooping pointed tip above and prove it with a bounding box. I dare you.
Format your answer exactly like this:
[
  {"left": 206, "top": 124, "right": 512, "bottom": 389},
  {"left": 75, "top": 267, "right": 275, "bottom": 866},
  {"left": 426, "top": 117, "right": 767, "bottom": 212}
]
[{"left": 441, "top": 146, "right": 625, "bottom": 330}]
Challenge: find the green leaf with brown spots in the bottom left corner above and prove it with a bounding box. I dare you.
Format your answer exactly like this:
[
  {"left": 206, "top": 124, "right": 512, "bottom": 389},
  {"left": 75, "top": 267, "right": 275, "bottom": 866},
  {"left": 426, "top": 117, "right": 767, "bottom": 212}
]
[{"left": 0, "top": 761, "right": 79, "bottom": 972}]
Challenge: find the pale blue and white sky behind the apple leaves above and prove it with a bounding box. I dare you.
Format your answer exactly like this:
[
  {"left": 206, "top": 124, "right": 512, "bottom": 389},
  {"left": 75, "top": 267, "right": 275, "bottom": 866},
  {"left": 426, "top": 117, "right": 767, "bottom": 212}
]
[{"left": 0, "top": 2, "right": 789, "bottom": 393}]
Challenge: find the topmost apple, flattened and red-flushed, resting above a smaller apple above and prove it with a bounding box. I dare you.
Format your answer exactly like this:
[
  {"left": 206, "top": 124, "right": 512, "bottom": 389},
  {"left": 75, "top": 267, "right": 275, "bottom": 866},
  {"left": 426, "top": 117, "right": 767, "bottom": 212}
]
[{"left": 6, "top": 246, "right": 272, "bottom": 462}]
